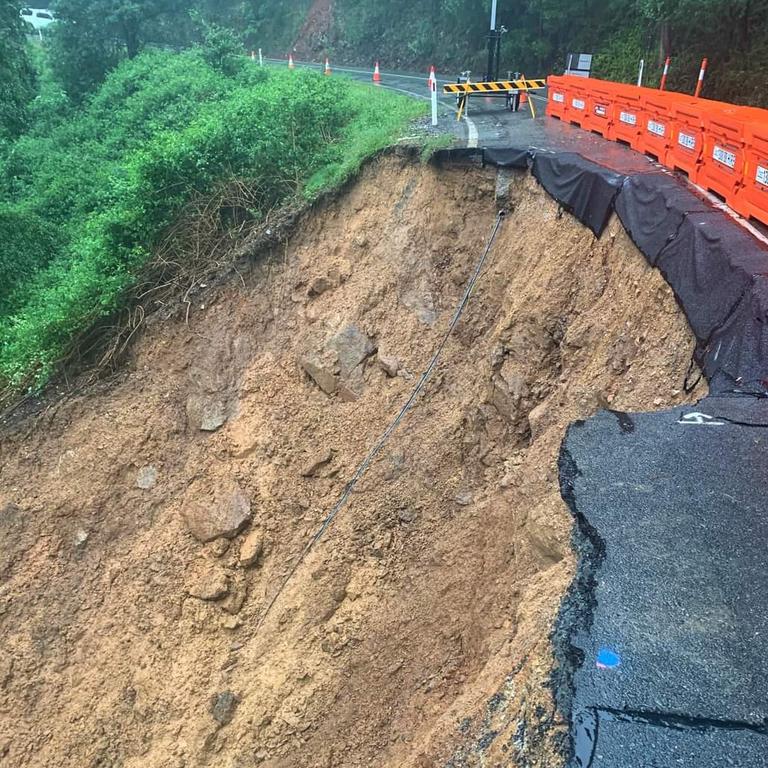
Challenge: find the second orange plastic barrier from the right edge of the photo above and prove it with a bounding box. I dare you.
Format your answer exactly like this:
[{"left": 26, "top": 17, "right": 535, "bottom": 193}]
[{"left": 696, "top": 109, "right": 748, "bottom": 208}]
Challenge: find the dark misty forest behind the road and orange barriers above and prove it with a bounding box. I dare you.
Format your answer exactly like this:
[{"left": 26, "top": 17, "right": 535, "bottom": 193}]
[{"left": 326, "top": 0, "right": 768, "bottom": 106}]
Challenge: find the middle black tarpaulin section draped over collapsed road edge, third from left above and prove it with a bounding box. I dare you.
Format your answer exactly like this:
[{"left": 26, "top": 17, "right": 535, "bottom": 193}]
[{"left": 615, "top": 173, "right": 712, "bottom": 265}]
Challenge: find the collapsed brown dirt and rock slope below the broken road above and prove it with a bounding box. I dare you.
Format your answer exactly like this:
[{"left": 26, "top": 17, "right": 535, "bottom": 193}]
[{"left": 0, "top": 158, "right": 704, "bottom": 768}]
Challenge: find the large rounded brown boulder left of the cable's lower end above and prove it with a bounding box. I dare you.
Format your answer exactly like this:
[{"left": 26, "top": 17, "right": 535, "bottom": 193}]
[{"left": 181, "top": 481, "right": 251, "bottom": 542}]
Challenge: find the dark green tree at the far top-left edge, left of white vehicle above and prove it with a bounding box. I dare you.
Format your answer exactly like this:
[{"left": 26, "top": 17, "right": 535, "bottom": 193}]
[{"left": 0, "top": 0, "right": 35, "bottom": 139}]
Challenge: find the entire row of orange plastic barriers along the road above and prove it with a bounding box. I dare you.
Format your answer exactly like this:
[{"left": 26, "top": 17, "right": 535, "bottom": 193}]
[{"left": 547, "top": 75, "right": 768, "bottom": 225}]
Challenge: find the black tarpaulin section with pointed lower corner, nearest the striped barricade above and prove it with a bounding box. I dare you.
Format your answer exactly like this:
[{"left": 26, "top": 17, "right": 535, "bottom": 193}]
[{"left": 533, "top": 152, "right": 624, "bottom": 237}]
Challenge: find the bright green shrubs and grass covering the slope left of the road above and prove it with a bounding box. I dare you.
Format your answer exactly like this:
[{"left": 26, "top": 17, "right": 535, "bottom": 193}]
[{"left": 0, "top": 40, "right": 422, "bottom": 387}]
